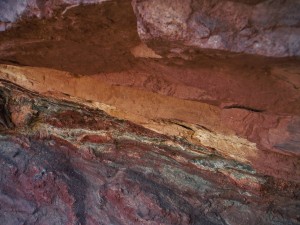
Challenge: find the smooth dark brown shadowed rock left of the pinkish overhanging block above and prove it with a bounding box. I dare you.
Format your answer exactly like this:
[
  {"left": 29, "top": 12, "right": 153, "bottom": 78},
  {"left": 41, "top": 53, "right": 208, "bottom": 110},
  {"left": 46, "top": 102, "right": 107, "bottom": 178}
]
[{"left": 0, "top": 1, "right": 140, "bottom": 74}]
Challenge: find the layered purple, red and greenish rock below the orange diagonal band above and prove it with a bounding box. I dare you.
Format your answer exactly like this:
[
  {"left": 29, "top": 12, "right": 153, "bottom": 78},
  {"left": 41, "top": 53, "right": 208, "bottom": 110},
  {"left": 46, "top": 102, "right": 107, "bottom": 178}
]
[{"left": 0, "top": 81, "right": 300, "bottom": 225}]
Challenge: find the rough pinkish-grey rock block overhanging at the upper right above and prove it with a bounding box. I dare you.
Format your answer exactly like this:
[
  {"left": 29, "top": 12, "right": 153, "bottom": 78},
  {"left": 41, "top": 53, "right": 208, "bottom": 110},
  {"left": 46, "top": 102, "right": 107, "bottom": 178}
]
[{"left": 133, "top": 0, "right": 300, "bottom": 57}]
